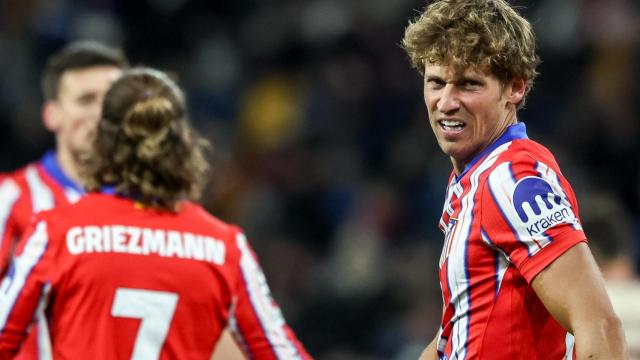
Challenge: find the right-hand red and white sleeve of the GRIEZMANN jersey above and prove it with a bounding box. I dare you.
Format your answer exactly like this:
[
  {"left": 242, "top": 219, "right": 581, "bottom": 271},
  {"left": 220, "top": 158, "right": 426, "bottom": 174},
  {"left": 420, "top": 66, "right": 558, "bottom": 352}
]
[{"left": 229, "top": 233, "right": 311, "bottom": 359}]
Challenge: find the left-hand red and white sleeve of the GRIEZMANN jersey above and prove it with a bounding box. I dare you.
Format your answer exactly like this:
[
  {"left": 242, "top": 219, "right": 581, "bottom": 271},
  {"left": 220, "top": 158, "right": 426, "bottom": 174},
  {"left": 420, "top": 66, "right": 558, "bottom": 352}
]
[{"left": 0, "top": 220, "right": 50, "bottom": 359}]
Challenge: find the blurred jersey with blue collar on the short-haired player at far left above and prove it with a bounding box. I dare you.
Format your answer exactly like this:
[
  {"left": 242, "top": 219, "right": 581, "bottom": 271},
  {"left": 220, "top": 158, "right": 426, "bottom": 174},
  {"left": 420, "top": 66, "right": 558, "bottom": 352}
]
[{"left": 0, "top": 151, "right": 84, "bottom": 360}]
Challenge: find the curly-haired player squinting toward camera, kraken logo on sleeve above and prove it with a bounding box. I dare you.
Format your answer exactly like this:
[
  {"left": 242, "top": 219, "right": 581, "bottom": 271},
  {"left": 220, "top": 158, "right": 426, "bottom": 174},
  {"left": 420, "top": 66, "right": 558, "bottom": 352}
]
[{"left": 403, "top": 0, "right": 628, "bottom": 359}]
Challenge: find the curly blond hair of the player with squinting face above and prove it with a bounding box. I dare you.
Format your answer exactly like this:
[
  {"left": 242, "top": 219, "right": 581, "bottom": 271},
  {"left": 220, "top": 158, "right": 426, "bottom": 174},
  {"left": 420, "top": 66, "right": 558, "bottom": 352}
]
[{"left": 402, "top": 0, "right": 540, "bottom": 107}]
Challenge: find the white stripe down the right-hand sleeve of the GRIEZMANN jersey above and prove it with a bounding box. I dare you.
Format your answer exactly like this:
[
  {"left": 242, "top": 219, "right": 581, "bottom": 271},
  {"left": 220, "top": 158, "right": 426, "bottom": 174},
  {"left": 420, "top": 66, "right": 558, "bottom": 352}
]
[{"left": 236, "top": 234, "right": 300, "bottom": 359}]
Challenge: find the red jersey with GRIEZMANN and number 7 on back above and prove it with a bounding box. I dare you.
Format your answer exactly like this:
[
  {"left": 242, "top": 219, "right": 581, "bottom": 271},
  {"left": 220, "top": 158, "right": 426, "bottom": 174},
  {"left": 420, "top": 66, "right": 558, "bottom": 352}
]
[{"left": 0, "top": 193, "right": 310, "bottom": 360}]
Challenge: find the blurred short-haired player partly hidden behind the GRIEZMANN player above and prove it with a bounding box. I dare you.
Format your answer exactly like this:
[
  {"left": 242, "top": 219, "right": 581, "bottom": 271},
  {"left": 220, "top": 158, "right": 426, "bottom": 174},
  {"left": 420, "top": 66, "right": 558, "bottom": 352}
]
[{"left": 0, "top": 41, "right": 128, "bottom": 359}]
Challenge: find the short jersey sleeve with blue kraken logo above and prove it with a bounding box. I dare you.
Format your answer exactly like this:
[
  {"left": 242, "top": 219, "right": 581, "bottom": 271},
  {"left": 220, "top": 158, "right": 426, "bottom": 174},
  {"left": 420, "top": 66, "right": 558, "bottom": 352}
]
[{"left": 481, "top": 156, "right": 586, "bottom": 283}]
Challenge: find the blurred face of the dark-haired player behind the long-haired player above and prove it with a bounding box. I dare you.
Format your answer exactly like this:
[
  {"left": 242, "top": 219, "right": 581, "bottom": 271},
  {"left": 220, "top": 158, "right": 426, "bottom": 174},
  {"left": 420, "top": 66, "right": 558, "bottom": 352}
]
[{"left": 48, "top": 66, "right": 122, "bottom": 158}]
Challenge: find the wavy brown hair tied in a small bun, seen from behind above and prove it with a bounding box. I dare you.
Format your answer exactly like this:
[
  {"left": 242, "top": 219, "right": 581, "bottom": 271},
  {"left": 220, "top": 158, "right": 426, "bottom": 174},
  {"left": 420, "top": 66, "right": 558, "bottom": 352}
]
[{"left": 85, "top": 68, "right": 209, "bottom": 211}]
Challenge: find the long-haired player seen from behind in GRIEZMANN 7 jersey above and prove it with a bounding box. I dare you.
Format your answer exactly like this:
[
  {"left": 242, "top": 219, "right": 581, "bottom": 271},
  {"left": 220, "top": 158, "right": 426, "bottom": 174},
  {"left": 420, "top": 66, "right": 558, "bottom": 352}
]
[{"left": 0, "top": 68, "right": 310, "bottom": 360}]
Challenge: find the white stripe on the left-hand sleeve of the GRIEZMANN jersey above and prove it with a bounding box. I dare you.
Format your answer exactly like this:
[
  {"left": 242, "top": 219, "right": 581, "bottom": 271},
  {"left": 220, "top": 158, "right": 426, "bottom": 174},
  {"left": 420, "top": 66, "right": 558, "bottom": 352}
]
[{"left": 0, "top": 221, "right": 49, "bottom": 329}]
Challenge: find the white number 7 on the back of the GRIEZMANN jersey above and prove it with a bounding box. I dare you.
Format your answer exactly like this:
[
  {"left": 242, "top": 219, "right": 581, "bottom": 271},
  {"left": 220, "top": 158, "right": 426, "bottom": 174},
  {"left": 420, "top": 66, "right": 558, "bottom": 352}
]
[{"left": 111, "top": 288, "right": 178, "bottom": 360}]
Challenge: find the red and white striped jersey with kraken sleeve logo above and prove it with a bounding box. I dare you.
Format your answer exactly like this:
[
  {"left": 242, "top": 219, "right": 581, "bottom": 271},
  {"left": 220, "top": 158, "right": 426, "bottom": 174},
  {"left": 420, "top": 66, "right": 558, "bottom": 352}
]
[{"left": 438, "top": 123, "right": 586, "bottom": 360}]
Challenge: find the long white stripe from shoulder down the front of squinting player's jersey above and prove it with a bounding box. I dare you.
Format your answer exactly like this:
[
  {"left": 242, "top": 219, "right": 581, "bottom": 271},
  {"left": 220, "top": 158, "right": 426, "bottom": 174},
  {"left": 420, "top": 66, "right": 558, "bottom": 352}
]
[{"left": 447, "top": 142, "right": 511, "bottom": 359}]
